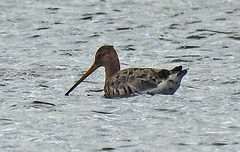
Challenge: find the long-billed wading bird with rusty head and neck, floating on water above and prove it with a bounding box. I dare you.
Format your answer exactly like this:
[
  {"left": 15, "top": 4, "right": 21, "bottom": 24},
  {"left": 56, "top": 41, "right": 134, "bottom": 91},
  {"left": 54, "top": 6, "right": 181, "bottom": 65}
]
[{"left": 65, "top": 45, "right": 188, "bottom": 98}]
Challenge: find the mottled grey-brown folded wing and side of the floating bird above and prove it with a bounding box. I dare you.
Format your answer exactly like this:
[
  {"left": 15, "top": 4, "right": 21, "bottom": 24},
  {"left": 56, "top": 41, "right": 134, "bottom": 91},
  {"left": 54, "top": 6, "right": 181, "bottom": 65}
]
[{"left": 104, "top": 68, "right": 172, "bottom": 97}]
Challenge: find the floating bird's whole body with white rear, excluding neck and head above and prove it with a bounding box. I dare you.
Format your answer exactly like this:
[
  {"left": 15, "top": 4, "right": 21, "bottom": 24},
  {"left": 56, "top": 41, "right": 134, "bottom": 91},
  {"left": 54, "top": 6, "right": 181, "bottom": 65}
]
[{"left": 104, "top": 66, "right": 187, "bottom": 98}]
